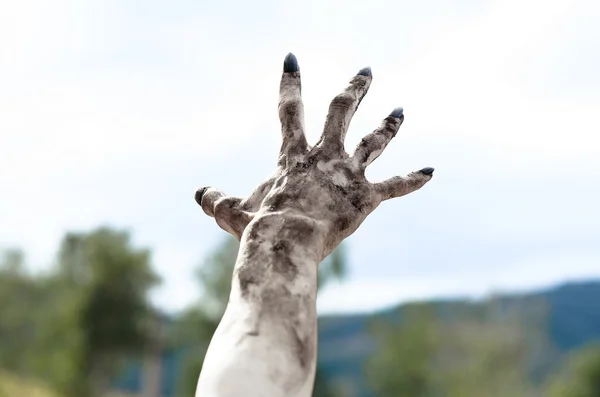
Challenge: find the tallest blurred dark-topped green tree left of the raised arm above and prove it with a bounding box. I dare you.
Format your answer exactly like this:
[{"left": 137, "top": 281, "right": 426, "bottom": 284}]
[{"left": 37, "top": 228, "right": 159, "bottom": 397}]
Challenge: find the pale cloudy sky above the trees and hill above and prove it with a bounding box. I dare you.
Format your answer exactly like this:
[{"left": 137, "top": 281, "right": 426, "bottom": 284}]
[{"left": 0, "top": 0, "right": 600, "bottom": 313}]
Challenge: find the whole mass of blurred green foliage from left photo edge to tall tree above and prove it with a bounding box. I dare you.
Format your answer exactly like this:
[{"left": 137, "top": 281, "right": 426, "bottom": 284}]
[{"left": 0, "top": 228, "right": 159, "bottom": 397}]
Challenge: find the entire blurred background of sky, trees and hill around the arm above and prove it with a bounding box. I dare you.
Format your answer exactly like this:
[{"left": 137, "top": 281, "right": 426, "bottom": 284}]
[{"left": 0, "top": 0, "right": 600, "bottom": 397}]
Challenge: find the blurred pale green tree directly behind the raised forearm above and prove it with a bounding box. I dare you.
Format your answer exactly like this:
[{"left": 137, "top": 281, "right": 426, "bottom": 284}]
[{"left": 171, "top": 236, "right": 347, "bottom": 397}]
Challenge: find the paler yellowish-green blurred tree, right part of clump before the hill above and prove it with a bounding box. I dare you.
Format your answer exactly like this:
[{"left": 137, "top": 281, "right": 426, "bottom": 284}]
[{"left": 437, "top": 298, "right": 544, "bottom": 397}]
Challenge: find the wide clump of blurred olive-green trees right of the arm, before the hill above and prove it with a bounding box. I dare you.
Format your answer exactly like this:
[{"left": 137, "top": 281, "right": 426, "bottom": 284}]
[{"left": 366, "top": 298, "right": 552, "bottom": 397}]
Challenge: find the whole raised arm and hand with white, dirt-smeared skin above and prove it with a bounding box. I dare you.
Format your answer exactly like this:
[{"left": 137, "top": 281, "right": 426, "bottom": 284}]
[{"left": 196, "top": 54, "right": 433, "bottom": 397}]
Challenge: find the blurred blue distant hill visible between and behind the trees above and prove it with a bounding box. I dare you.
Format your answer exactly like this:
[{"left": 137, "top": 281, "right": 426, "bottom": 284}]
[{"left": 110, "top": 280, "right": 600, "bottom": 397}]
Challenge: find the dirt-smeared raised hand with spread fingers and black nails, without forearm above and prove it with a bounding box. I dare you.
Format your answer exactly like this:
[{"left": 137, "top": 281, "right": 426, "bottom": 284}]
[{"left": 195, "top": 53, "right": 433, "bottom": 255}]
